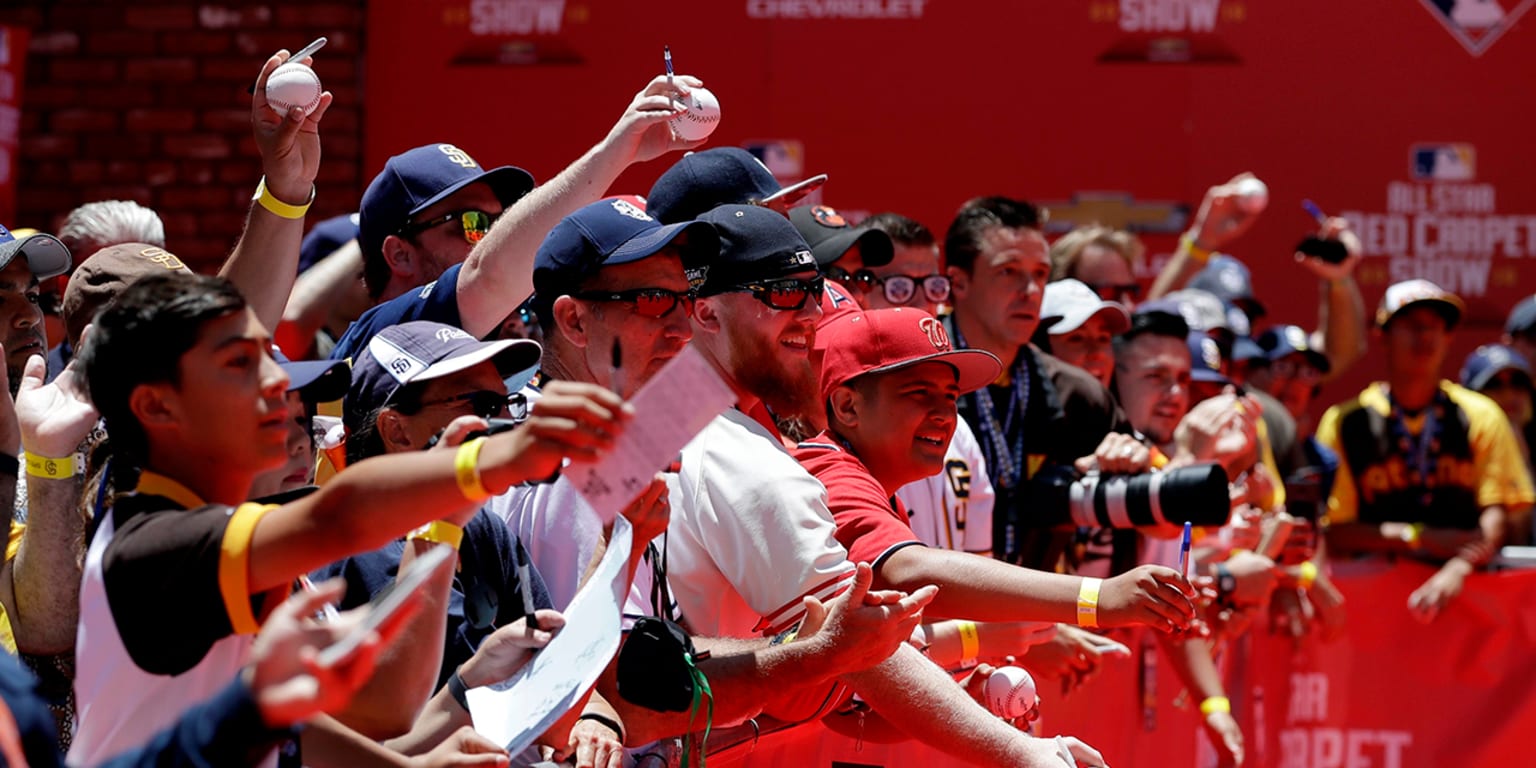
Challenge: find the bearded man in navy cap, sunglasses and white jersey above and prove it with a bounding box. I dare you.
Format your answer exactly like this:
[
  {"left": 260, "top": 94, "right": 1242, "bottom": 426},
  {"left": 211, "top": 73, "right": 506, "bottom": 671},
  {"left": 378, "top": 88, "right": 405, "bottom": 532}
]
[{"left": 667, "top": 206, "right": 1105, "bottom": 766}]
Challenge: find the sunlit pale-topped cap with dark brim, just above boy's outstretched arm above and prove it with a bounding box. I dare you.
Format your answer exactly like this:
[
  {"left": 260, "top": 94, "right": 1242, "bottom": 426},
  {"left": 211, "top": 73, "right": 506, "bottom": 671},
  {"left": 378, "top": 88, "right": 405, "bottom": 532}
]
[{"left": 343, "top": 319, "right": 542, "bottom": 432}]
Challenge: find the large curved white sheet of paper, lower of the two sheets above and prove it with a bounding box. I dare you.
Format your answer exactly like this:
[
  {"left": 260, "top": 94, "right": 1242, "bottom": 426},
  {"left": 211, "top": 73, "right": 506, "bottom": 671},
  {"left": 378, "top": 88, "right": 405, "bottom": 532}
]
[{"left": 468, "top": 518, "right": 630, "bottom": 756}]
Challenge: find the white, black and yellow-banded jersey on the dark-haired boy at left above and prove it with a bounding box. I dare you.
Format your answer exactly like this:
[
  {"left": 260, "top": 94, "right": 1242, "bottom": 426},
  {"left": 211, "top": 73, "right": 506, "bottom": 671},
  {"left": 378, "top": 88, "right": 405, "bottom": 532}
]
[{"left": 69, "top": 472, "right": 287, "bottom": 765}]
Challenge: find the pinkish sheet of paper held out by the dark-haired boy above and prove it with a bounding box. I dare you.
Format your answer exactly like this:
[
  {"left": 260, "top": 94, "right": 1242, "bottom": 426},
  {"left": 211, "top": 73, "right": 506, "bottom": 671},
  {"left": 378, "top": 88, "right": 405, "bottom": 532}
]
[{"left": 562, "top": 346, "right": 736, "bottom": 524}]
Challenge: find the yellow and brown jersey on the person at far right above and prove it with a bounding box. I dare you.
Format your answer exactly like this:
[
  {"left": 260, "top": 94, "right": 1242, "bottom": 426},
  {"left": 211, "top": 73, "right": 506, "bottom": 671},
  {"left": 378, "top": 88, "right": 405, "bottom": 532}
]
[{"left": 1318, "top": 381, "right": 1536, "bottom": 530}]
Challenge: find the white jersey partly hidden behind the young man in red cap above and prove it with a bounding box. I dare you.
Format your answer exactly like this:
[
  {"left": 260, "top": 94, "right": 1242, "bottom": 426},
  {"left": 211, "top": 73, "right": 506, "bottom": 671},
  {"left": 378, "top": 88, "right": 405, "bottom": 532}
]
[{"left": 895, "top": 419, "right": 997, "bottom": 553}]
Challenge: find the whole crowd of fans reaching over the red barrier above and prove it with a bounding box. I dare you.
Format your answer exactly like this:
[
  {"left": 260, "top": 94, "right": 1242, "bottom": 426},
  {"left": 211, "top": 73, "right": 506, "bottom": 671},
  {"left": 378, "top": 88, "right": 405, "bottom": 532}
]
[{"left": 0, "top": 52, "right": 1536, "bottom": 768}]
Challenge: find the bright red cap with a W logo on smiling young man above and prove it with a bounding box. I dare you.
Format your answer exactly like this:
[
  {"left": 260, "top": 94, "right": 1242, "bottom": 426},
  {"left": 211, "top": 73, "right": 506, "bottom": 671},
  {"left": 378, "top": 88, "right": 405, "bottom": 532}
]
[{"left": 816, "top": 307, "right": 1003, "bottom": 398}]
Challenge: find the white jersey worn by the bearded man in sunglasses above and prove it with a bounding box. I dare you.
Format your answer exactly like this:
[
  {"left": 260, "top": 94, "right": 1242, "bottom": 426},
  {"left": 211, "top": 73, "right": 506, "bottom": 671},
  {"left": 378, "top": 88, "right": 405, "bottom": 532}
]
[{"left": 666, "top": 410, "right": 854, "bottom": 637}]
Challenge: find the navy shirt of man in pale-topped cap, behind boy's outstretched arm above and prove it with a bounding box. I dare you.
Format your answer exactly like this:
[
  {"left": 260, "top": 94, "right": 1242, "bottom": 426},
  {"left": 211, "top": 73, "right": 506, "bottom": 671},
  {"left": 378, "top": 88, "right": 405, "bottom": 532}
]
[{"left": 312, "top": 510, "right": 553, "bottom": 688}]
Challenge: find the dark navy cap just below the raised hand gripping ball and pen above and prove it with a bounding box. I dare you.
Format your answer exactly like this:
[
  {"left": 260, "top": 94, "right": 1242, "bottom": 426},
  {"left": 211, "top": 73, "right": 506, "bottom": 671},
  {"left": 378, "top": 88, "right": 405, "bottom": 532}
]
[{"left": 645, "top": 146, "right": 826, "bottom": 224}]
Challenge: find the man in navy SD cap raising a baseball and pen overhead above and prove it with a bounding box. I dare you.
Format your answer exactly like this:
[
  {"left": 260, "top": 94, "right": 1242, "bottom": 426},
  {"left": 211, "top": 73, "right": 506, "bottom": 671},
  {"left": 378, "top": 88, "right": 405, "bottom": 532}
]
[{"left": 330, "top": 75, "right": 703, "bottom": 359}]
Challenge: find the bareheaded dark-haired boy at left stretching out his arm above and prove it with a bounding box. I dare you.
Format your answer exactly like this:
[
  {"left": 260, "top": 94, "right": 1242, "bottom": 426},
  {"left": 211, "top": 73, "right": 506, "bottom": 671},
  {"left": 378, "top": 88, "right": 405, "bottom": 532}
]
[{"left": 69, "top": 275, "right": 625, "bottom": 765}]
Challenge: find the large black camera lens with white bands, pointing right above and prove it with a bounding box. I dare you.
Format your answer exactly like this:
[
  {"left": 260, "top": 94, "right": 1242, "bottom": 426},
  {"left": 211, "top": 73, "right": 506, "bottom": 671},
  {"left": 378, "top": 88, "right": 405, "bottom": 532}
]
[{"left": 1025, "top": 462, "right": 1232, "bottom": 528}]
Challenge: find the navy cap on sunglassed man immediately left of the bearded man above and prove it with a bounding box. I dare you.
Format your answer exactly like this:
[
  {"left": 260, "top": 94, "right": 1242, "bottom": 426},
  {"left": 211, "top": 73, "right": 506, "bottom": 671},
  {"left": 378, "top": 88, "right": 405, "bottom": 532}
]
[{"left": 528, "top": 198, "right": 720, "bottom": 321}]
